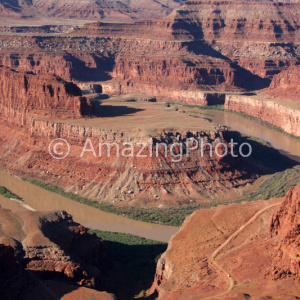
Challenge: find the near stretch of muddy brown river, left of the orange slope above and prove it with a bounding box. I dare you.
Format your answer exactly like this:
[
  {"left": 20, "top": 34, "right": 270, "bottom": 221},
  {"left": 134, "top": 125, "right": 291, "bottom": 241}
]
[{"left": 0, "top": 171, "right": 179, "bottom": 242}]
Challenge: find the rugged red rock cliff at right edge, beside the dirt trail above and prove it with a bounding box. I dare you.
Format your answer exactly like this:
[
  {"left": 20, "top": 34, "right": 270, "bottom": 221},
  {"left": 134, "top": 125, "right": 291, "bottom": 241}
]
[{"left": 269, "top": 182, "right": 300, "bottom": 280}]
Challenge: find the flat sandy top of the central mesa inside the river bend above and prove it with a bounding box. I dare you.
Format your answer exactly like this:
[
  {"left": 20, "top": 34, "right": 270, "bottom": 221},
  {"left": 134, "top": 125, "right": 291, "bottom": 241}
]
[{"left": 42, "top": 97, "right": 216, "bottom": 133}]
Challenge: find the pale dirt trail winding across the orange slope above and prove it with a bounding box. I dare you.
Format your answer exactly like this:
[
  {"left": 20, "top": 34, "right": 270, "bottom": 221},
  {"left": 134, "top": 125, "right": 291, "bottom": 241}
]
[{"left": 202, "top": 199, "right": 281, "bottom": 300}]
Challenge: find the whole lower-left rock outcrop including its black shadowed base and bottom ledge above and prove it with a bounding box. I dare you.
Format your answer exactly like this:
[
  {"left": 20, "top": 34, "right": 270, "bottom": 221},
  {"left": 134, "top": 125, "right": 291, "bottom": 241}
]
[{"left": 0, "top": 208, "right": 116, "bottom": 300}]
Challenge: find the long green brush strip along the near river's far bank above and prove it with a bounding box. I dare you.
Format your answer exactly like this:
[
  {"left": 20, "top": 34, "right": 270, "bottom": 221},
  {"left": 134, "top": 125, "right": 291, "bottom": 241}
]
[{"left": 23, "top": 165, "right": 300, "bottom": 226}]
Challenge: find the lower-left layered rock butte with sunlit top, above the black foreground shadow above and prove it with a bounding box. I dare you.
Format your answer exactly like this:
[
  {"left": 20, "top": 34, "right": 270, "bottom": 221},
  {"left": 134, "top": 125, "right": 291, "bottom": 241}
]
[{"left": 0, "top": 208, "right": 106, "bottom": 288}]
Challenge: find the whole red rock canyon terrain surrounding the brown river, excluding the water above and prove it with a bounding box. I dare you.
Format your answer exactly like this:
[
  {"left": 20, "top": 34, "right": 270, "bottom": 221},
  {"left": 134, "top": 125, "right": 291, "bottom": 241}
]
[{"left": 0, "top": 0, "right": 300, "bottom": 300}]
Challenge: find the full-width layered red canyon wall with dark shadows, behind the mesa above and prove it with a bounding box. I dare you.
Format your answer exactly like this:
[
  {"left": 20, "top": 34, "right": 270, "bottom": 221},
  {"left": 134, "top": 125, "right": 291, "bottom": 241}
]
[{"left": 0, "top": 1, "right": 300, "bottom": 105}]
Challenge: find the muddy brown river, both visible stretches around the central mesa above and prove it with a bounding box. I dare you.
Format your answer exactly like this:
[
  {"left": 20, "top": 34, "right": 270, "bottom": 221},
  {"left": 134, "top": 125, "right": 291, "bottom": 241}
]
[{"left": 0, "top": 111, "right": 300, "bottom": 242}]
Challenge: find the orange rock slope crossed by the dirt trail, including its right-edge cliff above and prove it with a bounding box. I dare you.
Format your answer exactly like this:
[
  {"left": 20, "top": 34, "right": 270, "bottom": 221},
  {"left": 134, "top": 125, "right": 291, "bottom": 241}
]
[{"left": 152, "top": 185, "right": 300, "bottom": 299}]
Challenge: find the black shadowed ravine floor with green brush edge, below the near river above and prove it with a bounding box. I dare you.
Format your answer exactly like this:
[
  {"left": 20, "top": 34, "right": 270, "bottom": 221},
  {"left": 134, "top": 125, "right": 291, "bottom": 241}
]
[{"left": 89, "top": 229, "right": 168, "bottom": 299}]
